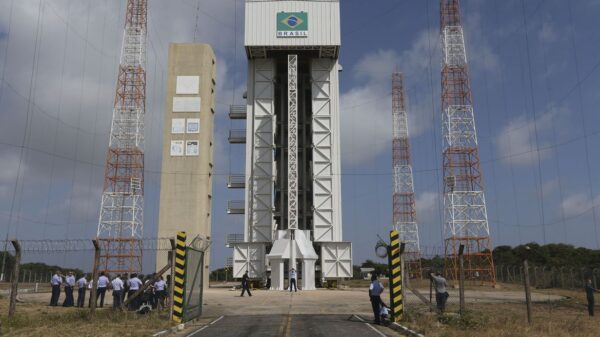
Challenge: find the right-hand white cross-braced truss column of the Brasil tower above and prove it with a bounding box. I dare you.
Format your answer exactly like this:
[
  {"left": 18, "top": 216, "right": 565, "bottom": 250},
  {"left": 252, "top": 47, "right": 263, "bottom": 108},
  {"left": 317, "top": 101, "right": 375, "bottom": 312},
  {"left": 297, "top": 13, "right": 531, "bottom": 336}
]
[{"left": 311, "top": 59, "right": 341, "bottom": 242}]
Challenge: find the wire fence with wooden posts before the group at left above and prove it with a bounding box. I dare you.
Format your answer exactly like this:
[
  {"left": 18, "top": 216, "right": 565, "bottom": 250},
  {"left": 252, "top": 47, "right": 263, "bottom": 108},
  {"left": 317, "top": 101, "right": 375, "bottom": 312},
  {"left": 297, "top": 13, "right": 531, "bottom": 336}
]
[{"left": 0, "top": 238, "right": 208, "bottom": 320}]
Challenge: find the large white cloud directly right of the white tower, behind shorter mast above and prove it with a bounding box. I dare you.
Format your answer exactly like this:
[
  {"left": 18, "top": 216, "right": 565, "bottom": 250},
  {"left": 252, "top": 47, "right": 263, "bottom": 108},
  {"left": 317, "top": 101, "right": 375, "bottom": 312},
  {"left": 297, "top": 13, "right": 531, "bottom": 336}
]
[{"left": 341, "top": 31, "right": 439, "bottom": 165}]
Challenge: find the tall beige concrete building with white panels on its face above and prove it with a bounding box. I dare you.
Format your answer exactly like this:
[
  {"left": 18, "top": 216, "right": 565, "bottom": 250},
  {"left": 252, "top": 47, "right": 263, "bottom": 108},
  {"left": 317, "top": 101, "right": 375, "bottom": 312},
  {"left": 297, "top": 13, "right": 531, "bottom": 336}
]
[{"left": 157, "top": 43, "right": 216, "bottom": 287}]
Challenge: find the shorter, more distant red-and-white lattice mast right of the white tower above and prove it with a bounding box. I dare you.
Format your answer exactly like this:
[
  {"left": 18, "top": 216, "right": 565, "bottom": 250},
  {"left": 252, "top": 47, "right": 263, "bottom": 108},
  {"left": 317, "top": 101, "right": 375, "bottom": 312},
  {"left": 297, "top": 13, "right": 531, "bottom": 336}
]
[{"left": 392, "top": 73, "right": 421, "bottom": 278}]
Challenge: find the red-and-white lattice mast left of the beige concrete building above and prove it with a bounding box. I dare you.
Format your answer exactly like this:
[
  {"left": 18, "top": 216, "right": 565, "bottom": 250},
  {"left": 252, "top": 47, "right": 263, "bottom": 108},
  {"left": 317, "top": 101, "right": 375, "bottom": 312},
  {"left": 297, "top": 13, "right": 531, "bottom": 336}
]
[{"left": 97, "top": 0, "right": 147, "bottom": 273}]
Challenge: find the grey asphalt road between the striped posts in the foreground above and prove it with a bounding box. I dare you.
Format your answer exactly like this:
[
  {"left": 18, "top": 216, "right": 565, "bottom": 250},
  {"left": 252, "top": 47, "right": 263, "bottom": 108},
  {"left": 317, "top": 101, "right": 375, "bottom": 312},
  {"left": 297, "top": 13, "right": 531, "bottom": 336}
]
[{"left": 186, "top": 315, "right": 399, "bottom": 337}]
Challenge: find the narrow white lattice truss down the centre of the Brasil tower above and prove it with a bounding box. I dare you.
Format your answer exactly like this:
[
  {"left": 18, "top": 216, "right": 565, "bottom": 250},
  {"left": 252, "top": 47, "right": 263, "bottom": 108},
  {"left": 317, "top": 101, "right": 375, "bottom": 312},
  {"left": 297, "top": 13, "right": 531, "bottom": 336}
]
[{"left": 287, "top": 55, "right": 298, "bottom": 229}]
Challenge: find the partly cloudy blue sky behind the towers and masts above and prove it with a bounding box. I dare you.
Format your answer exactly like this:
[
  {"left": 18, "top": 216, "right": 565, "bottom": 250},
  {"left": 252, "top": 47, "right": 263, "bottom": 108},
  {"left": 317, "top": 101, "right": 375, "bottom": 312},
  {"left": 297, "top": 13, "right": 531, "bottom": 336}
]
[{"left": 0, "top": 0, "right": 600, "bottom": 268}]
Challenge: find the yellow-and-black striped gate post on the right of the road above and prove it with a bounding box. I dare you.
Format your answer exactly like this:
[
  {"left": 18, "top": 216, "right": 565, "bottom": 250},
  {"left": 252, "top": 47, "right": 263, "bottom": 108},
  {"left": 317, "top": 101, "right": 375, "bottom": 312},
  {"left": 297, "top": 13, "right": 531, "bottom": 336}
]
[{"left": 388, "top": 230, "right": 404, "bottom": 322}]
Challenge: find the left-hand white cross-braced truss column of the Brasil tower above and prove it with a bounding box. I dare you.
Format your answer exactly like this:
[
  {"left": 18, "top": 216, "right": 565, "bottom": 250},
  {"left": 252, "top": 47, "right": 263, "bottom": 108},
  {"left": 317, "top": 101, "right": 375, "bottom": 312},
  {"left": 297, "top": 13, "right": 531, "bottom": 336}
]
[{"left": 246, "top": 59, "right": 275, "bottom": 243}]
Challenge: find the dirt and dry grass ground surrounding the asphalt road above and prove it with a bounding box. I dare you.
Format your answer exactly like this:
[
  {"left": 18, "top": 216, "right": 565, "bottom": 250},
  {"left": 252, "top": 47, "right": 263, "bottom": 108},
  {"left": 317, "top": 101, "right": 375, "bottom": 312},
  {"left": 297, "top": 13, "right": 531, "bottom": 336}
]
[{"left": 0, "top": 285, "right": 600, "bottom": 337}]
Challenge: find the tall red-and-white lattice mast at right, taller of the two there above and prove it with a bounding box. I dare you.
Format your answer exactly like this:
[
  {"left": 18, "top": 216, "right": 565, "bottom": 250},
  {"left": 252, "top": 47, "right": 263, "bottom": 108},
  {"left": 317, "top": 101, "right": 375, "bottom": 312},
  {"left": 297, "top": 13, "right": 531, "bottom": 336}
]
[{"left": 440, "top": 0, "right": 495, "bottom": 283}]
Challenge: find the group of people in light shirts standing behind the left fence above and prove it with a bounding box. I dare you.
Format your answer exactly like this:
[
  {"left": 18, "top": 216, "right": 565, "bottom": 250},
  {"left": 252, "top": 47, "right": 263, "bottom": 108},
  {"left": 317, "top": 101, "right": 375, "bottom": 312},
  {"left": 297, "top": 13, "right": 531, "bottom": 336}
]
[{"left": 50, "top": 271, "right": 170, "bottom": 310}]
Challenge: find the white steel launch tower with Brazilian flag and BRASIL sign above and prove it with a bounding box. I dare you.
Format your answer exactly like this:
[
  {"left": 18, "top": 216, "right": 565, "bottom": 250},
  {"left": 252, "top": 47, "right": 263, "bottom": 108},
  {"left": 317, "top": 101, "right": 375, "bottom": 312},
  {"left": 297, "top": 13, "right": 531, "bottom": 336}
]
[{"left": 232, "top": 0, "right": 352, "bottom": 290}]
